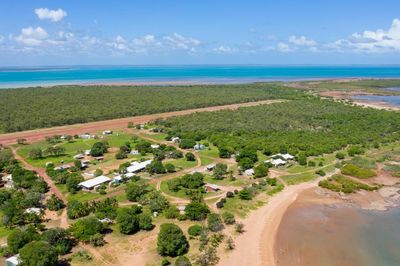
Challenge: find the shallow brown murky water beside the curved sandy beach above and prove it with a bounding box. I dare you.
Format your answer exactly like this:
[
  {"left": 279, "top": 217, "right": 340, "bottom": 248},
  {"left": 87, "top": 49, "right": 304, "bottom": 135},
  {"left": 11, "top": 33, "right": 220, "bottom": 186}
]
[{"left": 276, "top": 203, "right": 400, "bottom": 266}]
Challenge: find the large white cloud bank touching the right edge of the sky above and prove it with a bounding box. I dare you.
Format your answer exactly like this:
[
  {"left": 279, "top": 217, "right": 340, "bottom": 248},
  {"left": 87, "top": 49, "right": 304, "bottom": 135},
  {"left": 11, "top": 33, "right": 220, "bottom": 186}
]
[{"left": 327, "top": 18, "right": 400, "bottom": 53}]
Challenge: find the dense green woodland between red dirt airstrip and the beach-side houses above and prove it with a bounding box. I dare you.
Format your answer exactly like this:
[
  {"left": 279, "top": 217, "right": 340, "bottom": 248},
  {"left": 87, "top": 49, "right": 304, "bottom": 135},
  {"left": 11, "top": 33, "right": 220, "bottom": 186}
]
[{"left": 155, "top": 98, "right": 400, "bottom": 160}]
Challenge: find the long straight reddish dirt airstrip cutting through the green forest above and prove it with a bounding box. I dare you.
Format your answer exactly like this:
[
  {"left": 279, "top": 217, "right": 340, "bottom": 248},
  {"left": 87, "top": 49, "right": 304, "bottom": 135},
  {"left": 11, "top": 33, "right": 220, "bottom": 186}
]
[{"left": 0, "top": 100, "right": 281, "bottom": 146}]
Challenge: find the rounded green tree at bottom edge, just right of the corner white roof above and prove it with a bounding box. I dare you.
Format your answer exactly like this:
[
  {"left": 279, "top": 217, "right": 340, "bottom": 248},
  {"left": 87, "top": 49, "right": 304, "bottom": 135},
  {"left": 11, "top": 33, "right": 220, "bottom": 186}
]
[{"left": 19, "top": 241, "right": 58, "bottom": 266}]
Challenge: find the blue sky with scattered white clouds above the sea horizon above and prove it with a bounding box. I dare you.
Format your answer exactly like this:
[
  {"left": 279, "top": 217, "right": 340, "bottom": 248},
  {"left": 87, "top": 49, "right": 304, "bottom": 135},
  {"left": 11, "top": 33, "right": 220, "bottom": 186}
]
[{"left": 0, "top": 0, "right": 400, "bottom": 66}]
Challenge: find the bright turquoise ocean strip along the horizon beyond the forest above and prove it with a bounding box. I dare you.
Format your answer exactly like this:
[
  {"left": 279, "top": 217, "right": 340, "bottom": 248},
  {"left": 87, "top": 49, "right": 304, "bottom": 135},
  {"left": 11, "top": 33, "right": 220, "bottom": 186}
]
[{"left": 0, "top": 65, "right": 400, "bottom": 88}]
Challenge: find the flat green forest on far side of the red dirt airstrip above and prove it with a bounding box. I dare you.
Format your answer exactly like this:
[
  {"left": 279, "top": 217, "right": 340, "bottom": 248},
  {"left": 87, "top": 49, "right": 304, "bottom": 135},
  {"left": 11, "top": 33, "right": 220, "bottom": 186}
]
[{"left": 0, "top": 83, "right": 302, "bottom": 132}]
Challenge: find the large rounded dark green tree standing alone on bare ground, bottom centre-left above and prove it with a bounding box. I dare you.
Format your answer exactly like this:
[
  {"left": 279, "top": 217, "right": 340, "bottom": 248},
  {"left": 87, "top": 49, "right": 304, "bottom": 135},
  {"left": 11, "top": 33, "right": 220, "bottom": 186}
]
[{"left": 157, "top": 223, "right": 189, "bottom": 257}]
